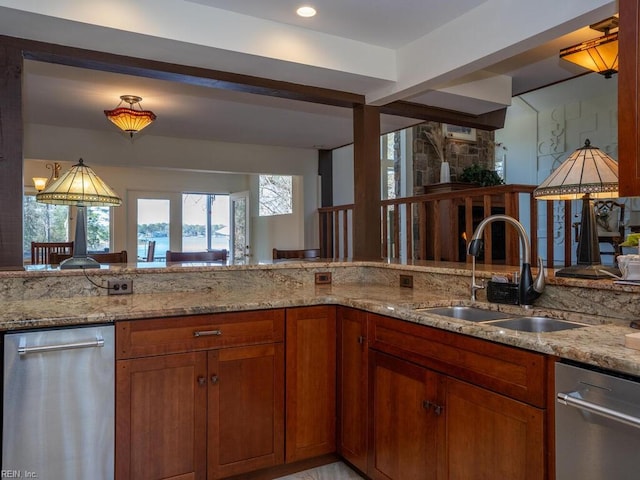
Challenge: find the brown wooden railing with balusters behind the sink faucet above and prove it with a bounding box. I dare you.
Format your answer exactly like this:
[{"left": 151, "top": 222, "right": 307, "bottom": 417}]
[{"left": 319, "top": 185, "right": 572, "bottom": 267}]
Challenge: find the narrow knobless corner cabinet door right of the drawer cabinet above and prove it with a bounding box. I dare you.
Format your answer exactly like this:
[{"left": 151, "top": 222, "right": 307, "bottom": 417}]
[{"left": 285, "top": 306, "right": 336, "bottom": 463}]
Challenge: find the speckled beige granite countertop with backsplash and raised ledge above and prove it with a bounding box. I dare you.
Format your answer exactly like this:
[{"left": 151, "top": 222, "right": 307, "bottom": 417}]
[{"left": 0, "top": 261, "right": 640, "bottom": 376}]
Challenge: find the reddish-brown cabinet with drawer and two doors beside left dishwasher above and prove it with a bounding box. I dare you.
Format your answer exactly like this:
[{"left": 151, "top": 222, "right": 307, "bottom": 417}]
[{"left": 116, "top": 310, "right": 284, "bottom": 480}]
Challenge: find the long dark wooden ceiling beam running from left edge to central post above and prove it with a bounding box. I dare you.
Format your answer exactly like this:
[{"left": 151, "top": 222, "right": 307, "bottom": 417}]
[{"left": 0, "top": 36, "right": 365, "bottom": 108}]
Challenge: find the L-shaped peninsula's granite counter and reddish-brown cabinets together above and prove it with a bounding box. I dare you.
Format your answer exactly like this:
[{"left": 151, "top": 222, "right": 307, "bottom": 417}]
[{"left": 0, "top": 260, "right": 640, "bottom": 480}]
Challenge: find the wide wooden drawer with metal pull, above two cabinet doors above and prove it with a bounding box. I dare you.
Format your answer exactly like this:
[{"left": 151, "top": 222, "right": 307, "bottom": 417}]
[{"left": 116, "top": 309, "right": 284, "bottom": 359}]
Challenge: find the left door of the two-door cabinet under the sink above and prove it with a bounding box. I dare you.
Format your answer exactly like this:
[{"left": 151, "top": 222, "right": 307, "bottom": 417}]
[{"left": 367, "top": 351, "right": 442, "bottom": 480}]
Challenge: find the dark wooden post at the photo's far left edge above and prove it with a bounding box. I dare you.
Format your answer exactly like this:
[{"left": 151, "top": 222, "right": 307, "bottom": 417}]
[{"left": 0, "top": 44, "right": 23, "bottom": 270}]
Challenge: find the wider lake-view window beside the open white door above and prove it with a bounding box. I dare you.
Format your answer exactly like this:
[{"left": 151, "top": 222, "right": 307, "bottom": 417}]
[{"left": 182, "top": 193, "right": 229, "bottom": 252}]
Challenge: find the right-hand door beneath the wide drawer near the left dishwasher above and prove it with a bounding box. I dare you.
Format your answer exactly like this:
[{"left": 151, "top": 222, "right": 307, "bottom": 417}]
[{"left": 208, "top": 343, "right": 284, "bottom": 479}]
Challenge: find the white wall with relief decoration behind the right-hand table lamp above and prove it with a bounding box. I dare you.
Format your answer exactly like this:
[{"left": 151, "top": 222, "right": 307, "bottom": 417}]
[{"left": 496, "top": 73, "right": 616, "bottom": 261}]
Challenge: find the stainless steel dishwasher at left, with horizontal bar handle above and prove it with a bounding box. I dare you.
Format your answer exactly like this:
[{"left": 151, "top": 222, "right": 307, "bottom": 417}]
[{"left": 2, "top": 325, "right": 115, "bottom": 480}]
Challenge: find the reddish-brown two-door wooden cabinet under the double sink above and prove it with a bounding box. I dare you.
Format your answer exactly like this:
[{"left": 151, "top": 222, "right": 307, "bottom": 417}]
[{"left": 368, "top": 315, "right": 548, "bottom": 480}]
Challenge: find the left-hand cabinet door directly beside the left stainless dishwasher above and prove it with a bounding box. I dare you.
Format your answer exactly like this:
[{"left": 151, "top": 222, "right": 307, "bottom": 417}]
[{"left": 116, "top": 353, "right": 207, "bottom": 480}]
